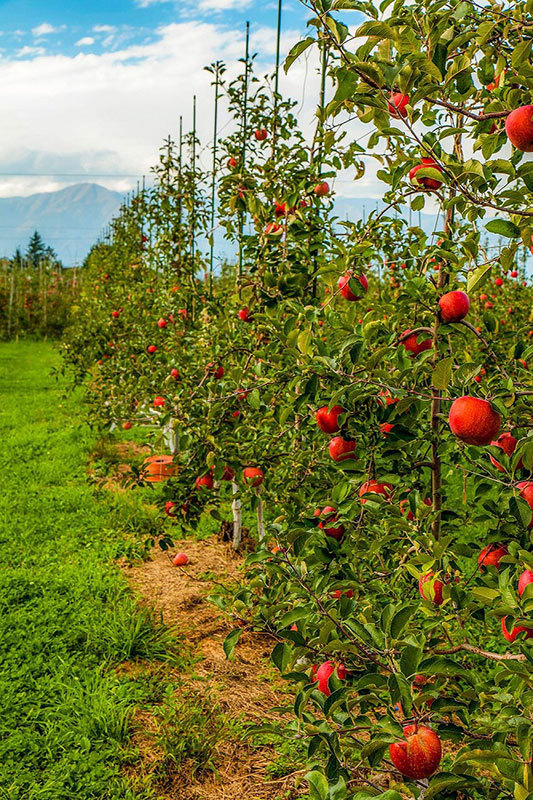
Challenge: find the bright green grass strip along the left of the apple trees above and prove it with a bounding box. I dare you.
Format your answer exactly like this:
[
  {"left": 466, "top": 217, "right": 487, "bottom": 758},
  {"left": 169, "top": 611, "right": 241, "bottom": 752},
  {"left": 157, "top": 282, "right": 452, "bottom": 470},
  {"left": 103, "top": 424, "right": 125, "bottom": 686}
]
[{"left": 0, "top": 342, "right": 181, "bottom": 800}]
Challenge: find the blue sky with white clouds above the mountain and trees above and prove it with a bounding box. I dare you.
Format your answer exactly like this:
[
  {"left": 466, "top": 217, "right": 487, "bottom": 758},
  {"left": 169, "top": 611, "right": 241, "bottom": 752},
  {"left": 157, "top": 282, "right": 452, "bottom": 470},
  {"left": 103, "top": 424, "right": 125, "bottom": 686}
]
[{"left": 0, "top": 0, "right": 340, "bottom": 197}]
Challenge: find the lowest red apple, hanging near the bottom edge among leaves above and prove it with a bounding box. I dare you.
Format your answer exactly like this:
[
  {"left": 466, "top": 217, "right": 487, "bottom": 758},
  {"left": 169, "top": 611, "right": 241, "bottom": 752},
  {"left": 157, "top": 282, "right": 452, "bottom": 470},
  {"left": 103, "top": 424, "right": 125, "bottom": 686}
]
[{"left": 389, "top": 723, "right": 442, "bottom": 780}]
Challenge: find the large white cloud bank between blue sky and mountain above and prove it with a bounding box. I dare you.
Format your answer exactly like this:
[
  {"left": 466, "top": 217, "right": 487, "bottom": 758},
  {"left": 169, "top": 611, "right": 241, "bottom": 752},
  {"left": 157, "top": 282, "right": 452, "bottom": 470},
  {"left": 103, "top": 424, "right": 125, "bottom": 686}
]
[{"left": 0, "top": 21, "right": 318, "bottom": 198}]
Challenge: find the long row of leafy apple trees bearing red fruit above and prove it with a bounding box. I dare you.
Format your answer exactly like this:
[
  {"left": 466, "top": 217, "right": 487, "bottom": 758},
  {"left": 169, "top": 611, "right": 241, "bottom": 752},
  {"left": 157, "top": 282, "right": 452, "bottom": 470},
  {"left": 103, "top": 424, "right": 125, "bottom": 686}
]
[{"left": 59, "top": 0, "right": 533, "bottom": 800}]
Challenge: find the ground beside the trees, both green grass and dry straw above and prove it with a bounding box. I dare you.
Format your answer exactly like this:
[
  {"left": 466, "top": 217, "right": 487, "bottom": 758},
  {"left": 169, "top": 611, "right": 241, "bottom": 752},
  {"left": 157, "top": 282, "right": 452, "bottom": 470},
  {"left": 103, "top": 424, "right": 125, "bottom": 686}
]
[{"left": 0, "top": 342, "right": 303, "bottom": 800}]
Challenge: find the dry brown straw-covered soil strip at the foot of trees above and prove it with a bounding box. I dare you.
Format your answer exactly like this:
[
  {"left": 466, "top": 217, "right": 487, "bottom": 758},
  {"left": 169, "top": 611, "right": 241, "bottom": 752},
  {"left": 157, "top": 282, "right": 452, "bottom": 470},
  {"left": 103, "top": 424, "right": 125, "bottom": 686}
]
[{"left": 102, "top": 454, "right": 307, "bottom": 800}]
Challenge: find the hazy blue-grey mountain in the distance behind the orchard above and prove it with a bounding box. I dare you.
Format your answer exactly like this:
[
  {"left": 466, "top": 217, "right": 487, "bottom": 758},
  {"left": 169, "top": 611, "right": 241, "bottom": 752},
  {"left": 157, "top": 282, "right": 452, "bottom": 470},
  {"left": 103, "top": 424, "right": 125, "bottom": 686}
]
[{"left": 0, "top": 183, "right": 123, "bottom": 267}]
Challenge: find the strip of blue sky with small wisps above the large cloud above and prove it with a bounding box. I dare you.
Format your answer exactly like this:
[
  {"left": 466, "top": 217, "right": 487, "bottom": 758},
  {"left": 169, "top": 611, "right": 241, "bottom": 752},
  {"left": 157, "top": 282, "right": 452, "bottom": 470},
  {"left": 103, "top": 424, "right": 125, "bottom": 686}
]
[{"left": 0, "top": 0, "right": 308, "bottom": 58}]
